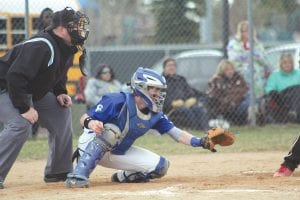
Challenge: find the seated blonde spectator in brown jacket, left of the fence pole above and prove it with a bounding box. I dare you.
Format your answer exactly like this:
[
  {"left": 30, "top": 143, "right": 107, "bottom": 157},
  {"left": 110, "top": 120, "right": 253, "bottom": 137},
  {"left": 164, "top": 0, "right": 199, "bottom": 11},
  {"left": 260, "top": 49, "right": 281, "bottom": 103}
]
[{"left": 207, "top": 59, "right": 249, "bottom": 125}]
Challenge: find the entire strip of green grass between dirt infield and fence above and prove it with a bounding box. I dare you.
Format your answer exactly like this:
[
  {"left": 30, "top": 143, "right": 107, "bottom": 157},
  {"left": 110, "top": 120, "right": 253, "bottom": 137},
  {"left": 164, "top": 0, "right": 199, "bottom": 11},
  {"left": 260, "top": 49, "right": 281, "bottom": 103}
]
[{"left": 18, "top": 124, "right": 300, "bottom": 160}]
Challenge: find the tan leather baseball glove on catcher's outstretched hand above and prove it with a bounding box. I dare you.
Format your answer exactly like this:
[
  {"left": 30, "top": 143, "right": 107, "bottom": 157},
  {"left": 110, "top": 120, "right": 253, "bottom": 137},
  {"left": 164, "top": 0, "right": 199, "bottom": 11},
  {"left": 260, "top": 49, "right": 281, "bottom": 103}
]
[{"left": 203, "top": 128, "right": 235, "bottom": 152}]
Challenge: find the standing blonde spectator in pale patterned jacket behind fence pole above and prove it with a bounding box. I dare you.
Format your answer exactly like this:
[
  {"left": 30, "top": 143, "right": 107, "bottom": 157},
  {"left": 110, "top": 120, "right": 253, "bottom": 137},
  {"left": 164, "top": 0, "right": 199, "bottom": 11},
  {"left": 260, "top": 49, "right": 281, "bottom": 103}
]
[{"left": 227, "top": 21, "right": 270, "bottom": 97}]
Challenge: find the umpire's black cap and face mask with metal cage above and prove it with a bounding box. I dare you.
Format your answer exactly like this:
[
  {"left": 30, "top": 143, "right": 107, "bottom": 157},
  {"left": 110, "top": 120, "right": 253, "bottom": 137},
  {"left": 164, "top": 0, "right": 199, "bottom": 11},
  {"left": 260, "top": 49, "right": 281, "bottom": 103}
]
[{"left": 51, "top": 7, "right": 90, "bottom": 45}]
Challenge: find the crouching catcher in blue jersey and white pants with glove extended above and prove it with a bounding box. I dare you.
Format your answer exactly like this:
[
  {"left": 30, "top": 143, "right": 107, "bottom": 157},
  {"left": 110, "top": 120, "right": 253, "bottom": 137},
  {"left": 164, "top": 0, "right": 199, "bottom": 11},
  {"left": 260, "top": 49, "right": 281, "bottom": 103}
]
[{"left": 65, "top": 68, "right": 234, "bottom": 187}]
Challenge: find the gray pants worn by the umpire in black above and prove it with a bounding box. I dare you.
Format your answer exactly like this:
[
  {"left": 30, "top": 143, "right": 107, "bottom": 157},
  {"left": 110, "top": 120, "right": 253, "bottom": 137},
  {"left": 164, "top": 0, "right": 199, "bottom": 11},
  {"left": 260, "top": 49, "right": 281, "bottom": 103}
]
[{"left": 0, "top": 90, "right": 73, "bottom": 181}]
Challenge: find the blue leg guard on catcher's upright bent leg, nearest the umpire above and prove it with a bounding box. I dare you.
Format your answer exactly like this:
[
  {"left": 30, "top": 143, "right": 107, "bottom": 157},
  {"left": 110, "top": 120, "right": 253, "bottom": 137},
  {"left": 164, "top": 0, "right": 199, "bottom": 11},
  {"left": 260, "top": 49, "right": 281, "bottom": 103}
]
[{"left": 65, "top": 124, "right": 121, "bottom": 187}]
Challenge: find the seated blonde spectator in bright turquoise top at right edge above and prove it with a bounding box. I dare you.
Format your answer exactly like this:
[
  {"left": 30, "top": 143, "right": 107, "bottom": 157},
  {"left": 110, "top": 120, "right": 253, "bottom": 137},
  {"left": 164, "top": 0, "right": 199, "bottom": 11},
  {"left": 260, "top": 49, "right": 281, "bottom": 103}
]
[{"left": 265, "top": 54, "right": 300, "bottom": 122}]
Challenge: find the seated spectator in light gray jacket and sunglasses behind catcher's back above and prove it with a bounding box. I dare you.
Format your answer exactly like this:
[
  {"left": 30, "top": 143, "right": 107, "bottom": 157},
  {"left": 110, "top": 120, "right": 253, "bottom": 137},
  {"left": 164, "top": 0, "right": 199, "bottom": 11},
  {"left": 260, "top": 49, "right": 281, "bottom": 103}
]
[{"left": 84, "top": 64, "right": 123, "bottom": 108}]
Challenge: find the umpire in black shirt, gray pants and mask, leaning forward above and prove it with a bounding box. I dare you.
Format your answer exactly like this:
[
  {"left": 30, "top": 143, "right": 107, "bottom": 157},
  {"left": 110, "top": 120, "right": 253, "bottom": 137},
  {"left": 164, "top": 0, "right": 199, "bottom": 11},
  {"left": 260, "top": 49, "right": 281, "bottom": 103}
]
[{"left": 0, "top": 7, "right": 89, "bottom": 188}]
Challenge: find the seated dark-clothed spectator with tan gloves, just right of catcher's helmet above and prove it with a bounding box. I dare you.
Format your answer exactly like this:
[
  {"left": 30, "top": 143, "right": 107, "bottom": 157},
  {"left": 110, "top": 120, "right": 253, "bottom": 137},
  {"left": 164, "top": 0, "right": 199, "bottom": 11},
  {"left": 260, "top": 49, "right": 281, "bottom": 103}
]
[{"left": 163, "top": 58, "right": 209, "bottom": 130}]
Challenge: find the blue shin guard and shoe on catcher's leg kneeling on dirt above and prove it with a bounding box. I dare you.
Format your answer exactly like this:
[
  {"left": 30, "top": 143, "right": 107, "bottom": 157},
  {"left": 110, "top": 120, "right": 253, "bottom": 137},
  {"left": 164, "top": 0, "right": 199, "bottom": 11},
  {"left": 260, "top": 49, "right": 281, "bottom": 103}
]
[{"left": 111, "top": 157, "right": 170, "bottom": 183}]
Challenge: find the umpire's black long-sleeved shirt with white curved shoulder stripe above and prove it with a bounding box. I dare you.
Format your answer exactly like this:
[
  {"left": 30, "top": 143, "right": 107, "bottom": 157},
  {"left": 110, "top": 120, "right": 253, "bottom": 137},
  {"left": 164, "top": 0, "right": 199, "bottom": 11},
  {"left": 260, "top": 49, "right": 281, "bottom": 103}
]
[{"left": 0, "top": 30, "right": 77, "bottom": 114}]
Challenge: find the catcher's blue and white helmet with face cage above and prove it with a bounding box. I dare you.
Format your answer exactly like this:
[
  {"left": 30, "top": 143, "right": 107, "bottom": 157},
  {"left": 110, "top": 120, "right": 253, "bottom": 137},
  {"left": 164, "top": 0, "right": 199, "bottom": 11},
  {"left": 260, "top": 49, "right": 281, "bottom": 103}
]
[{"left": 130, "top": 67, "right": 167, "bottom": 112}]
